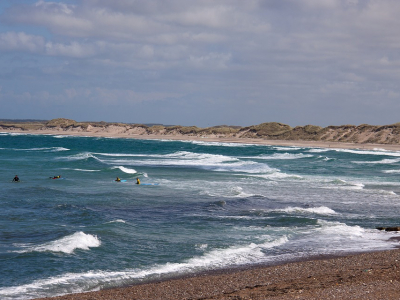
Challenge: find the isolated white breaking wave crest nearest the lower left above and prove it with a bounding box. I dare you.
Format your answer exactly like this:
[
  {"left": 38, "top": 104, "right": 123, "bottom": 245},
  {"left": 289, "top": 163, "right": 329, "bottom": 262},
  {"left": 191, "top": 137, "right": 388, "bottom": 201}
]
[{"left": 16, "top": 231, "right": 101, "bottom": 254}]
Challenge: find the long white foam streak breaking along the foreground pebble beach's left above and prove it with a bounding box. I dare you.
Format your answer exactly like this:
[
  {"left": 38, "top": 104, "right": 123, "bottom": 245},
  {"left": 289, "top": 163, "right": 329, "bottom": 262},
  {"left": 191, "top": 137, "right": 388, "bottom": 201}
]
[{"left": 0, "top": 236, "right": 288, "bottom": 299}]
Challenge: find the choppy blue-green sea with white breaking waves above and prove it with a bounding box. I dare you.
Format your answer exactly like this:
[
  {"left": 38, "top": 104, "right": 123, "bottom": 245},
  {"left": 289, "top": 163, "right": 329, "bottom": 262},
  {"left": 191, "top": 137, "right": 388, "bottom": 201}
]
[{"left": 0, "top": 133, "right": 400, "bottom": 299}]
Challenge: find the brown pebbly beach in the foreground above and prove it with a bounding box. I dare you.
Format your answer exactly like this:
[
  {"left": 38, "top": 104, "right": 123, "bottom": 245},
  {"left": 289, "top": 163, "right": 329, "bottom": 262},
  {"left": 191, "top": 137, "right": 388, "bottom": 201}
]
[{"left": 37, "top": 249, "right": 400, "bottom": 300}]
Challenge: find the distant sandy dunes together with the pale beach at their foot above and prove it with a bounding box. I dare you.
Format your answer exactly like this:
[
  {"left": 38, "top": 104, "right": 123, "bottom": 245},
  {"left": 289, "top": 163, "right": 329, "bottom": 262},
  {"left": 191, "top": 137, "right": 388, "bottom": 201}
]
[{"left": 0, "top": 119, "right": 400, "bottom": 150}]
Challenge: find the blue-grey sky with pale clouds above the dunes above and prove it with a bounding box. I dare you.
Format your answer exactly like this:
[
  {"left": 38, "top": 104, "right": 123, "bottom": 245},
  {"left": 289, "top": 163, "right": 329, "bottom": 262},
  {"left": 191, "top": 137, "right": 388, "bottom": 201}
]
[{"left": 0, "top": 0, "right": 400, "bottom": 127}]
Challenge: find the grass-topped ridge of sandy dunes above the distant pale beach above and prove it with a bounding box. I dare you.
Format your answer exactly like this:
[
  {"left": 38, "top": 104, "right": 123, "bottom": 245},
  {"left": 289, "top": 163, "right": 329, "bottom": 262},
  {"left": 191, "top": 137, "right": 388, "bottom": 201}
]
[{"left": 0, "top": 118, "right": 400, "bottom": 145}]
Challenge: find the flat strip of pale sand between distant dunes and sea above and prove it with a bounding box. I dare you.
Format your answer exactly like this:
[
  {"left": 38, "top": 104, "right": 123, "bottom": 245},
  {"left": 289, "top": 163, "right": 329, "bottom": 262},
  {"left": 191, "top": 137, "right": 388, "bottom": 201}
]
[{"left": 0, "top": 126, "right": 400, "bottom": 151}]
